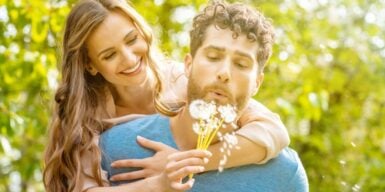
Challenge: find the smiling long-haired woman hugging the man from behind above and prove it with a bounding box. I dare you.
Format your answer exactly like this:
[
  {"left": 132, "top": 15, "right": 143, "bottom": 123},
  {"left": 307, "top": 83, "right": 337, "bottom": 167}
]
[{"left": 44, "top": 0, "right": 289, "bottom": 191}]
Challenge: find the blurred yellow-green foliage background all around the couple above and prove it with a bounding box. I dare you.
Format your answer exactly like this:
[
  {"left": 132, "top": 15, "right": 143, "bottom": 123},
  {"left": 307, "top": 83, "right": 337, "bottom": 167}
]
[{"left": 0, "top": 0, "right": 385, "bottom": 192}]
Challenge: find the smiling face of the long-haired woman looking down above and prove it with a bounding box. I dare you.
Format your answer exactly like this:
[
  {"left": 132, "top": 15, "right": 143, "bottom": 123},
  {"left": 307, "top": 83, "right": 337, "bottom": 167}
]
[{"left": 86, "top": 11, "right": 148, "bottom": 86}]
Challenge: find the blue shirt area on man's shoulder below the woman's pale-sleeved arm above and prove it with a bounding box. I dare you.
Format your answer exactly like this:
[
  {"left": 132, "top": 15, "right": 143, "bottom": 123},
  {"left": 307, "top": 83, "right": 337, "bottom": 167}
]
[{"left": 191, "top": 148, "right": 308, "bottom": 192}]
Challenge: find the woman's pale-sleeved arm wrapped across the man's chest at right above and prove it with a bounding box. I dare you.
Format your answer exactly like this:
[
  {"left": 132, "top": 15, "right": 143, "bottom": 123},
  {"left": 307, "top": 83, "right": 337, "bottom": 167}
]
[{"left": 201, "top": 99, "right": 290, "bottom": 171}]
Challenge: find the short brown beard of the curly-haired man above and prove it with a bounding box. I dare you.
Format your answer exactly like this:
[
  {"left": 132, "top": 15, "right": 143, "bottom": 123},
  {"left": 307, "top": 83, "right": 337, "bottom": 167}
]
[{"left": 187, "top": 76, "right": 251, "bottom": 111}]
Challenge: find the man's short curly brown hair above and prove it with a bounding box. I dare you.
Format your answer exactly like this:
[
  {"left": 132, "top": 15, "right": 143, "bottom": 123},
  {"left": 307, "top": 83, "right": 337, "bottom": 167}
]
[{"left": 190, "top": 1, "right": 275, "bottom": 72}]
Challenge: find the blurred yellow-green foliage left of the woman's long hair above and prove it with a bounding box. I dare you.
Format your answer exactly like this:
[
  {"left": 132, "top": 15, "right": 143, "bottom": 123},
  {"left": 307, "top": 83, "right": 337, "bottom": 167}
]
[{"left": 0, "top": 1, "right": 69, "bottom": 191}]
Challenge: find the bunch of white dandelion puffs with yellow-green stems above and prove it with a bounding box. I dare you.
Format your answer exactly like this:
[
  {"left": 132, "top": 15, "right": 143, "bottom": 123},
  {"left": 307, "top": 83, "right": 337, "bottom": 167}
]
[{"left": 189, "top": 100, "right": 238, "bottom": 178}]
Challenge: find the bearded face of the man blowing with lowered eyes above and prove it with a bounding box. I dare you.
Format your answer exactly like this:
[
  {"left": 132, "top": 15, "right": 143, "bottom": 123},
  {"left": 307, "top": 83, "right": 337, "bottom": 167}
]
[{"left": 185, "top": 26, "right": 263, "bottom": 111}]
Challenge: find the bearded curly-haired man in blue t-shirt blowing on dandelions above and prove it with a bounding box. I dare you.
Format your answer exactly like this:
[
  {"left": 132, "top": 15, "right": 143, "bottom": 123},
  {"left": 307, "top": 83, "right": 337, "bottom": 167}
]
[{"left": 100, "top": 3, "right": 308, "bottom": 191}]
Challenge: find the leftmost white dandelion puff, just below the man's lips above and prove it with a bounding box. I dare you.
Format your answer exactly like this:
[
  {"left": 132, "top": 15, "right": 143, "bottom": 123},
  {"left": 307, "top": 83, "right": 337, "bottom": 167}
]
[{"left": 189, "top": 100, "right": 217, "bottom": 120}]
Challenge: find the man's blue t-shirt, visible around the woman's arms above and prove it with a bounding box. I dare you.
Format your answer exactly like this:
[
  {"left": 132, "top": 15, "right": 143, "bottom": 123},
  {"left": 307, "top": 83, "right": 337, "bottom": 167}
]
[{"left": 99, "top": 114, "right": 309, "bottom": 192}]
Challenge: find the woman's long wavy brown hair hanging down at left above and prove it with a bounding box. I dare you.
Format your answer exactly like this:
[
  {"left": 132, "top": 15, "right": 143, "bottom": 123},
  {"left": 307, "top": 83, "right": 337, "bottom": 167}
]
[{"left": 43, "top": 0, "right": 161, "bottom": 192}]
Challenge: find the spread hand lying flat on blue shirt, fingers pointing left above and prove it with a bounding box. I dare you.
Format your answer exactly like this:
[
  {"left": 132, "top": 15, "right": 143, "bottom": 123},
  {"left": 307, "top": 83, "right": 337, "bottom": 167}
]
[{"left": 111, "top": 136, "right": 177, "bottom": 181}]
